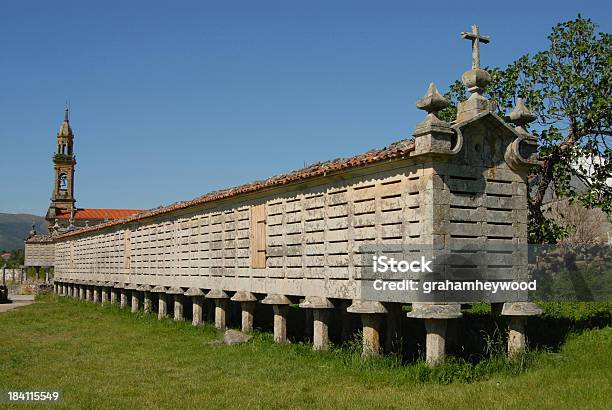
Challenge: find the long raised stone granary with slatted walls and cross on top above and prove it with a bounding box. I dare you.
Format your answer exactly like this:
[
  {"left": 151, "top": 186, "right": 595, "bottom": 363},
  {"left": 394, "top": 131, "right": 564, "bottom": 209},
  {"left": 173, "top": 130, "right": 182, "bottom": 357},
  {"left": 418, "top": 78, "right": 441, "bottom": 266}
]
[{"left": 54, "top": 26, "right": 538, "bottom": 365}]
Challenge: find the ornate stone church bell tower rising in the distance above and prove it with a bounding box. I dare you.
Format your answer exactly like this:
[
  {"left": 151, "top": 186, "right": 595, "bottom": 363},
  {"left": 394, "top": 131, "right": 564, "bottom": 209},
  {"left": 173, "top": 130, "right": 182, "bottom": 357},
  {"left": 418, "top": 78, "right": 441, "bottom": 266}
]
[{"left": 46, "top": 108, "right": 76, "bottom": 225}]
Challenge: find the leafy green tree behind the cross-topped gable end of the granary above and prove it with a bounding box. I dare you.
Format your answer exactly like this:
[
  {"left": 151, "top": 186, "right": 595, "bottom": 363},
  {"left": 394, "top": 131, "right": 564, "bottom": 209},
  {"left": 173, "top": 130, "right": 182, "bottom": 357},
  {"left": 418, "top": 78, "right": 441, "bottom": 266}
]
[{"left": 442, "top": 15, "right": 612, "bottom": 243}]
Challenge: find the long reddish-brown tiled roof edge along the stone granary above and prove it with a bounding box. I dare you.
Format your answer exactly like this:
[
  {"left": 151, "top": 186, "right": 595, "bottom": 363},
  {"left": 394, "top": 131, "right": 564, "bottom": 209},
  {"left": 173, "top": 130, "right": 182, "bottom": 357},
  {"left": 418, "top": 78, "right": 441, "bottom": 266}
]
[{"left": 55, "top": 139, "right": 414, "bottom": 238}]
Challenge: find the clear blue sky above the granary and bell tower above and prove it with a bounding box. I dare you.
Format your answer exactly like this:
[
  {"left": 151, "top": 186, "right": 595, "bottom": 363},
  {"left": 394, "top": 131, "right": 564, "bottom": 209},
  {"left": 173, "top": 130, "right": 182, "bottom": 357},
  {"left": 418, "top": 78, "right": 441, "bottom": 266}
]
[{"left": 0, "top": 0, "right": 612, "bottom": 215}]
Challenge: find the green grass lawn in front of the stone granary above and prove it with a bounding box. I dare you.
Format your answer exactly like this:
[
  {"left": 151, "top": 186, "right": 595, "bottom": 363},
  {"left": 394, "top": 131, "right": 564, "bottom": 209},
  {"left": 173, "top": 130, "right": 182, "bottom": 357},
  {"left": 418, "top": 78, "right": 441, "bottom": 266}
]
[{"left": 0, "top": 297, "right": 612, "bottom": 408}]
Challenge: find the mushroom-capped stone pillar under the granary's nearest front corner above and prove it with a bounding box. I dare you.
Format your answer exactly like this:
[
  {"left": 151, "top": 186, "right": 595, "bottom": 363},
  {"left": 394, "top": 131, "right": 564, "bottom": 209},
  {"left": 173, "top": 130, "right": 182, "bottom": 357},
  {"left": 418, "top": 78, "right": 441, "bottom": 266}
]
[{"left": 407, "top": 303, "right": 462, "bottom": 367}]
